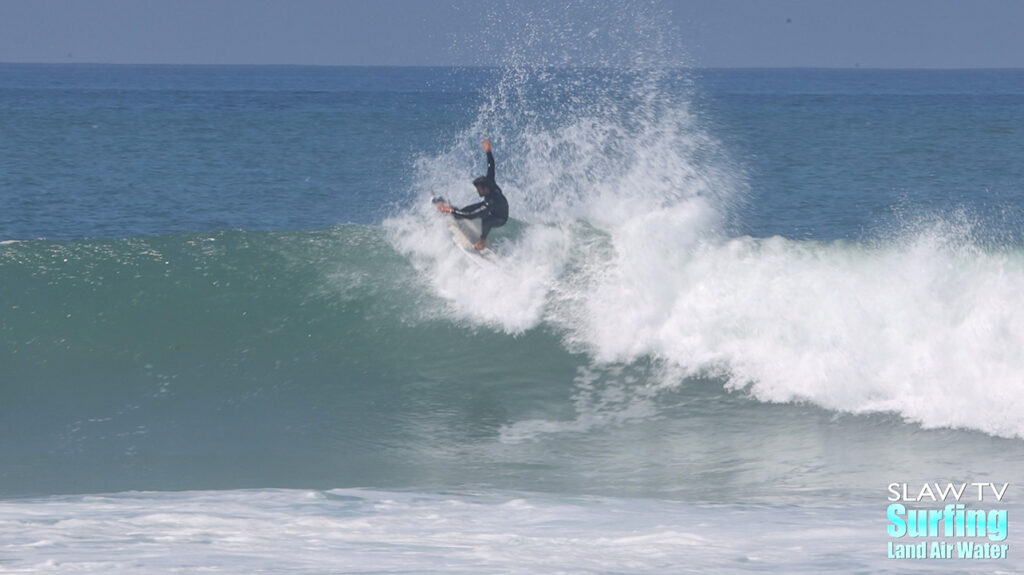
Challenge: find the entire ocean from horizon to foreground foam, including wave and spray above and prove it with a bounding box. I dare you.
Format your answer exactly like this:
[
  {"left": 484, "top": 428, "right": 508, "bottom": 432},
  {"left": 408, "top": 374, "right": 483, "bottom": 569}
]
[{"left": 0, "top": 29, "right": 1024, "bottom": 575}]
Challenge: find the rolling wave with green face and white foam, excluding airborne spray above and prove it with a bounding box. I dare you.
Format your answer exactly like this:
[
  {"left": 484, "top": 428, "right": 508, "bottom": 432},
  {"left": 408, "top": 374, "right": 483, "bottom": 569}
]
[{"left": 6, "top": 220, "right": 1024, "bottom": 502}]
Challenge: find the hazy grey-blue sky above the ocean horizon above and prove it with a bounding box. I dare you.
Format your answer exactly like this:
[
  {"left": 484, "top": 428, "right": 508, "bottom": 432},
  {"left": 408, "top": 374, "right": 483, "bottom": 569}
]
[{"left": 0, "top": 0, "right": 1024, "bottom": 68}]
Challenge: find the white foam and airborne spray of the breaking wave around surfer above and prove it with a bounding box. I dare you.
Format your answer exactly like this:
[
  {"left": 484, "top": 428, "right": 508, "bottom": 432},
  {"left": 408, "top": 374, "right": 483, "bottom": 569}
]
[{"left": 384, "top": 19, "right": 1024, "bottom": 437}]
